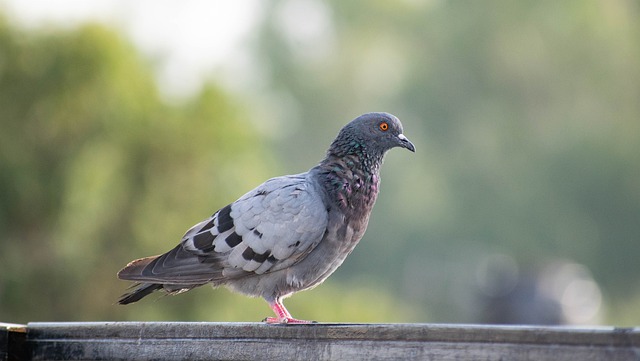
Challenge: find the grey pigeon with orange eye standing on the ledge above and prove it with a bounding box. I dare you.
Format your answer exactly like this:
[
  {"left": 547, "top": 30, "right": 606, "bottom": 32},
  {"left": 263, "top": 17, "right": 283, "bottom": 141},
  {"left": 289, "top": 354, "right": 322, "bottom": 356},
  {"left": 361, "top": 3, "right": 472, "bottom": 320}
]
[{"left": 118, "top": 112, "right": 415, "bottom": 324}]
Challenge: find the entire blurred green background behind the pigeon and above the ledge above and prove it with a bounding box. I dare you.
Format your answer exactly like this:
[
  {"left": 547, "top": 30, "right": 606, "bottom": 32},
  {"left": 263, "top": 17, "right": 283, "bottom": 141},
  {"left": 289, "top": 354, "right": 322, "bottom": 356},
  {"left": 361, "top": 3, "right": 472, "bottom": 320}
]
[{"left": 0, "top": 0, "right": 640, "bottom": 326}]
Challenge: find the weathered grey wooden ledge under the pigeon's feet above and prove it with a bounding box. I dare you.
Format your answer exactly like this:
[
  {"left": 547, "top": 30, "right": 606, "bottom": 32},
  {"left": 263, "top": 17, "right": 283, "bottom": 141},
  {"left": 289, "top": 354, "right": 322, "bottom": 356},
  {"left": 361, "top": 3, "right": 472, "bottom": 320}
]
[{"left": 0, "top": 322, "right": 640, "bottom": 361}]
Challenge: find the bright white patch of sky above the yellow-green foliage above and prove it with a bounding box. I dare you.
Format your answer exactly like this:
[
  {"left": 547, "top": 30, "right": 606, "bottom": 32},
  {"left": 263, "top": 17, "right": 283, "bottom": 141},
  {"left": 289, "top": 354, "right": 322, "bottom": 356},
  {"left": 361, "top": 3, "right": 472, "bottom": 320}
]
[{"left": 0, "top": 0, "right": 261, "bottom": 98}]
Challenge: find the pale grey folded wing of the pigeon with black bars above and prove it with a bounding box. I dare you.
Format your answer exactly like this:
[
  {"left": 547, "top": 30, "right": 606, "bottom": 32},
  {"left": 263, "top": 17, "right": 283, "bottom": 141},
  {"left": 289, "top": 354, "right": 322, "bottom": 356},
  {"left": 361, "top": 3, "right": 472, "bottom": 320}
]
[{"left": 120, "top": 173, "right": 328, "bottom": 284}]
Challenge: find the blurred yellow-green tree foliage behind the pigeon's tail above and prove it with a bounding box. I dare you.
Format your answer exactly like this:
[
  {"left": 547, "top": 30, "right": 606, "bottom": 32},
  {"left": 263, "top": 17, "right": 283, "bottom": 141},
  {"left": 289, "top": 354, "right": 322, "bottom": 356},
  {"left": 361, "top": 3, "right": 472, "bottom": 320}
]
[{"left": 0, "top": 19, "right": 270, "bottom": 322}]
